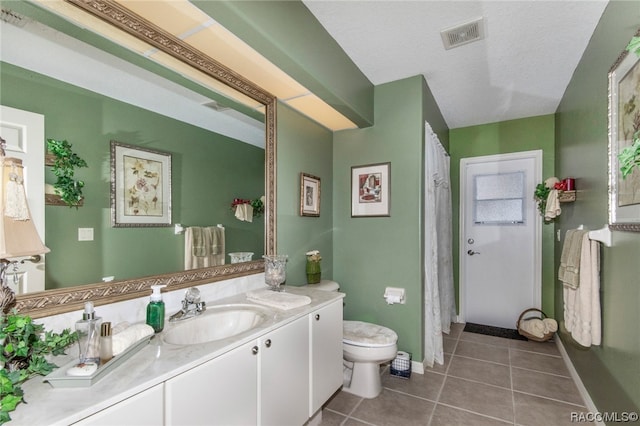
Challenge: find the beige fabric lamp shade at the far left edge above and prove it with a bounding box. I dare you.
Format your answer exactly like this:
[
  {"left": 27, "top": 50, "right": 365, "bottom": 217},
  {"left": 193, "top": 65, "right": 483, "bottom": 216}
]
[{"left": 0, "top": 156, "right": 50, "bottom": 259}]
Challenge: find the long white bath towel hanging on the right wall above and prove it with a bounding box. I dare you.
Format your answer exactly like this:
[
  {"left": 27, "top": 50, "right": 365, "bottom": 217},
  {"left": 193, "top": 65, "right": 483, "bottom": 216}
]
[{"left": 563, "top": 233, "right": 602, "bottom": 347}]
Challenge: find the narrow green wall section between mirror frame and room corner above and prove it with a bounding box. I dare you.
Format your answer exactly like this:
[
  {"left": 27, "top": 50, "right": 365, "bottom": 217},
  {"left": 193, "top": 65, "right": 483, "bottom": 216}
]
[{"left": 277, "top": 103, "right": 334, "bottom": 286}]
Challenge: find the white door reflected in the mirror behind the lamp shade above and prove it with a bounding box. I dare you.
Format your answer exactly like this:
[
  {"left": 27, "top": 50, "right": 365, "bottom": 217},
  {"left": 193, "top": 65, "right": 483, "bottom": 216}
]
[{"left": 0, "top": 106, "right": 45, "bottom": 294}]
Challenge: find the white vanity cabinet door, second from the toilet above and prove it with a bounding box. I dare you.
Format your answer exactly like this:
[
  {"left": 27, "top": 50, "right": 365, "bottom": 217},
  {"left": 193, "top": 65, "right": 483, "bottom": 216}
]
[{"left": 258, "top": 317, "right": 309, "bottom": 426}]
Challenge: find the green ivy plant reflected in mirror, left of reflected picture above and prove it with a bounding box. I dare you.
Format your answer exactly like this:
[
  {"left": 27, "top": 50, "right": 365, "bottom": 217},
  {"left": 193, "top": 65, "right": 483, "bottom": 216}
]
[{"left": 47, "top": 139, "right": 87, "bottom": 208}]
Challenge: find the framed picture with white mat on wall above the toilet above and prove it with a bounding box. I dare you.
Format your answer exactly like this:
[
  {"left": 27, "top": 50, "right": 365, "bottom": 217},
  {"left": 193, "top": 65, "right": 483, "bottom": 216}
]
[{"left": 351, "top": 163, "right": 391, "bottom": 217}]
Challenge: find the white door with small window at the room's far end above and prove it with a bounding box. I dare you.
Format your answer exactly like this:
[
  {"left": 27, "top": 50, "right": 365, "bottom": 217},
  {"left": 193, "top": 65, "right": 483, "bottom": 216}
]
[{"left": 460, "top": 151, "right": 542, "bottom": 329}]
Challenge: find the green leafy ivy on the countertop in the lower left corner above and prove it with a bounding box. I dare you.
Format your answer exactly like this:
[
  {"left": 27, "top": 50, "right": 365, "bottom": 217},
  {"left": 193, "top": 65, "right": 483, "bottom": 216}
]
[{"left": 0, "top": 311, "right": 78, "bottom": 425}]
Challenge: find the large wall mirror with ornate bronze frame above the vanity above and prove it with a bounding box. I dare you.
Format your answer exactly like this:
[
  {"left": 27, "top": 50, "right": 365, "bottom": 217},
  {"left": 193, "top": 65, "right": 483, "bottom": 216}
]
[{"left": 1, "top": 0, "right": 276, "bottom": 318}]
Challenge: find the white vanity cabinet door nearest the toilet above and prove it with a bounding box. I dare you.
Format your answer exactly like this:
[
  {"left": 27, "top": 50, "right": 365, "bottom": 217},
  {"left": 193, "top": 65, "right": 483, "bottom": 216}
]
[{"left": 309, "top": 299, "right": 343, "bottom": 417}]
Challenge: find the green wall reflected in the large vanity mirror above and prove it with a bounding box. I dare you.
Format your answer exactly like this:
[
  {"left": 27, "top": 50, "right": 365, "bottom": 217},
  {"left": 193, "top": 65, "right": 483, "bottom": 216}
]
[{"left": 0, "top": 63, "right": 264, "bottom": 289}]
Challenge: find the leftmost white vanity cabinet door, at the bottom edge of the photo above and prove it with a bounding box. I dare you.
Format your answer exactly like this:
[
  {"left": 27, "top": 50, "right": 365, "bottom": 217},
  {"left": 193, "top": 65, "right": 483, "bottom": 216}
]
[{"left": 74, "top": 384, "right": 164, "bottom": 426}]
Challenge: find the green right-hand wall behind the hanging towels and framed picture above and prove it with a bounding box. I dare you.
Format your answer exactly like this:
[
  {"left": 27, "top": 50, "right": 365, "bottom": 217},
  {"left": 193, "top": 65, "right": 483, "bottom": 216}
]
[{"left": 555, "top": 1, "right": 640, "bottom": 412}]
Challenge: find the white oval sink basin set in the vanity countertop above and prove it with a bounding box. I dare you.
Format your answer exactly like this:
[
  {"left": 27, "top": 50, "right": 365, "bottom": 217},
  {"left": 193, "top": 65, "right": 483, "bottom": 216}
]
[{"left": 163, "top": 304, "right": 268, "bottom": 345}]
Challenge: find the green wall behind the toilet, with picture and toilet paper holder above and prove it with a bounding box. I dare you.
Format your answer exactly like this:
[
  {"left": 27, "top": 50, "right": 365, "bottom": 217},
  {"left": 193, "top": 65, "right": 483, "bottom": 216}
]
[{"left": 333, "top": 77, "right": 438, "bottom": 361}]
